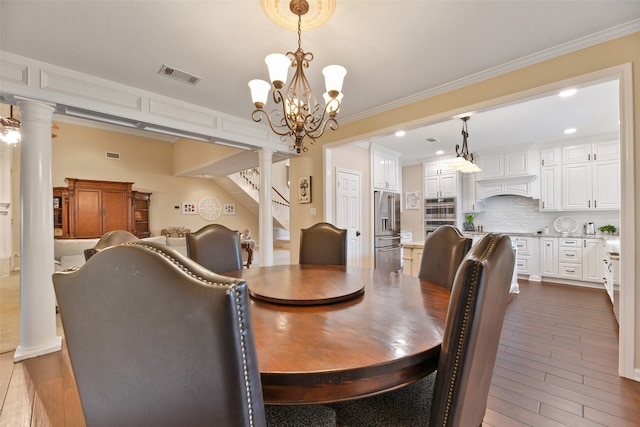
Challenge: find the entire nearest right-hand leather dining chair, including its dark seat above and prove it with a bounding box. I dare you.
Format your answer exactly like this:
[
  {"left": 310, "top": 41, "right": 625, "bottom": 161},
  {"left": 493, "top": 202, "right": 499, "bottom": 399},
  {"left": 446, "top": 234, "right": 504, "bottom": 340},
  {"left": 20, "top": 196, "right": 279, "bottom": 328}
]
[{"left": 330, "top": 233, "right": 515, "bottom": 427}]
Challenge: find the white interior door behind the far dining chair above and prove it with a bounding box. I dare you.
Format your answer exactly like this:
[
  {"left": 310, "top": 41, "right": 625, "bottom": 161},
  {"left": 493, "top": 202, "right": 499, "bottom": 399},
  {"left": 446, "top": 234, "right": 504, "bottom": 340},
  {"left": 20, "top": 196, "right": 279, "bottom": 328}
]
[{"left": 336, "top": 168, "right": 362, "bottom": 267}]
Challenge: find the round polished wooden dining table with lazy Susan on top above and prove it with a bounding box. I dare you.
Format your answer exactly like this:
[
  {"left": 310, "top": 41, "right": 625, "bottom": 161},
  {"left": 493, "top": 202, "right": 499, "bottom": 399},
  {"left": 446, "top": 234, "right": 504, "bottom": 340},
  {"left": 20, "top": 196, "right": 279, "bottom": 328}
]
[{"left": 224, "top": 264, "right": 450, "bottom": 404}]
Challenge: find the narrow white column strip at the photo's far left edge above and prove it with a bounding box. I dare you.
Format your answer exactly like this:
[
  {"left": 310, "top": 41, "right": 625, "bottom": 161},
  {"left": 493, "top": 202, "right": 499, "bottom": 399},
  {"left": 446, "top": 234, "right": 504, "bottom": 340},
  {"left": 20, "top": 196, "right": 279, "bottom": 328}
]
[{"left": 0, "top": 141, "right": 13, "bottom": 276}]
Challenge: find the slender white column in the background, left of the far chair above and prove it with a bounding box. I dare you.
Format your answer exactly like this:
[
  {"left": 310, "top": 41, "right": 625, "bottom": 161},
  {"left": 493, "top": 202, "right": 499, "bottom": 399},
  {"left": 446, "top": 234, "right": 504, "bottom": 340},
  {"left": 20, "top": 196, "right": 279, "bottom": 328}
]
[{"left": 258, "top": 148, "right": 273, "bottom": 266}]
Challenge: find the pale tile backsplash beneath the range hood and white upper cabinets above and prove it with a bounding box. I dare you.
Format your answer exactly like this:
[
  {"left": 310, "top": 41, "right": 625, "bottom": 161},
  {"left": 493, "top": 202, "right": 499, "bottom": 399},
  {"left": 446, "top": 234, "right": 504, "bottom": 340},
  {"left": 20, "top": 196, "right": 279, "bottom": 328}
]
[{"left": 474, "top": 196, "right": 620, "bottom": 234}]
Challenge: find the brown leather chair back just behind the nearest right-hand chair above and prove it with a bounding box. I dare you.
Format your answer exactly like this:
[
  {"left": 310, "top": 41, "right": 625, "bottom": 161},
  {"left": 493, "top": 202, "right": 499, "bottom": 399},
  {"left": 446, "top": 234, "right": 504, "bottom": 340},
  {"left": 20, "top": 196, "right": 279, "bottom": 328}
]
[{"left": 418, "top": 225, "right": 473, "bottom": 290}]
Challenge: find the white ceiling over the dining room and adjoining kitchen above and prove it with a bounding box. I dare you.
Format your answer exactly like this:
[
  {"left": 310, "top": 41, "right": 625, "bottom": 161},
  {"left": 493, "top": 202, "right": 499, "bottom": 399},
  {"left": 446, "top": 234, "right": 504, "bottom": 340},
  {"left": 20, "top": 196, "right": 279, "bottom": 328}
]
[{"left": 0, "top": 0, "right": 640, "bottom": 159}]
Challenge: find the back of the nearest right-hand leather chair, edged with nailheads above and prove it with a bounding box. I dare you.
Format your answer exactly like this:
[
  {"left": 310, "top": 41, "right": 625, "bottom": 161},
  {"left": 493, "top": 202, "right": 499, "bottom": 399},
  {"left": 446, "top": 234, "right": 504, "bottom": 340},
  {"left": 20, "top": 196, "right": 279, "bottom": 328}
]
[{"left": 429, "top": 233, "right": 515, "bottom": 427}]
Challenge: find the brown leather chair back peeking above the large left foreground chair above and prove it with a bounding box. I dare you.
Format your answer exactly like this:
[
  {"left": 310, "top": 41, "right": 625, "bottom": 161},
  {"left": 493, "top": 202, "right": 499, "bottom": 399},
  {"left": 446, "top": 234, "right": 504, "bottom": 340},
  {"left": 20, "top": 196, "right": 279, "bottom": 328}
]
[{"left": 185, "top": 224, "right": 242, "bottom": 273}]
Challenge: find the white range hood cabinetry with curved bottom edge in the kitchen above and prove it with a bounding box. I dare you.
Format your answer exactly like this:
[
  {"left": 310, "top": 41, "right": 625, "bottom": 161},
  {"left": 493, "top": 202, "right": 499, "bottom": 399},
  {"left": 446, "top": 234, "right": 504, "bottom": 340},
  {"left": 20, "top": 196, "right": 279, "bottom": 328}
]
[{"left": 476, "top": 148, "right": 539, "bottom": 199}]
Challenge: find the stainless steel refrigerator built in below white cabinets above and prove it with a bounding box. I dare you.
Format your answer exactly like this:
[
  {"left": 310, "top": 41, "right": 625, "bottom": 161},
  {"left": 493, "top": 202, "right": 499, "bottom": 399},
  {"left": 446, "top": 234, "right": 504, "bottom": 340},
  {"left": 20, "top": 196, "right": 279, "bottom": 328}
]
[{"left": 373, "top": 191, "right": 402, "bottom": 272}]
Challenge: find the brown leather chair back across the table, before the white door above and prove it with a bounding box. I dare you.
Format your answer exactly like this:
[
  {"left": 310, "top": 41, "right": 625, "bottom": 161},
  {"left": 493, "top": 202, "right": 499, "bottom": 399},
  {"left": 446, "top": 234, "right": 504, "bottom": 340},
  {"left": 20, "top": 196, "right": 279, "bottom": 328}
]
[{"left": 299, "top": 222, "right": 347, "bottom": 265}]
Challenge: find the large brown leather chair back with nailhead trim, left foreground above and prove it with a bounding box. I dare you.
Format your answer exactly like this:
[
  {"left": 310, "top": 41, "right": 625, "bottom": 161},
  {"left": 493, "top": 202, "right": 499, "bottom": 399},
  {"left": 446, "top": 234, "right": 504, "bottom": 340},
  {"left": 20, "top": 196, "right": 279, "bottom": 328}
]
[{"left": 53, "top": 241, "right": 265, "bottom": 426}]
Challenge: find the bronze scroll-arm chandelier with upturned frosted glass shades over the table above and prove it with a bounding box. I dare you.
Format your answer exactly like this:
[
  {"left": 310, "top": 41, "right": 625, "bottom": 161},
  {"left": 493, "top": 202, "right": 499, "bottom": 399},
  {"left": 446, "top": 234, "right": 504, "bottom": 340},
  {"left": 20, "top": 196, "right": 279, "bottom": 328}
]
[{"left": 249, "top": 0, "right": 347, "bottom": 153}]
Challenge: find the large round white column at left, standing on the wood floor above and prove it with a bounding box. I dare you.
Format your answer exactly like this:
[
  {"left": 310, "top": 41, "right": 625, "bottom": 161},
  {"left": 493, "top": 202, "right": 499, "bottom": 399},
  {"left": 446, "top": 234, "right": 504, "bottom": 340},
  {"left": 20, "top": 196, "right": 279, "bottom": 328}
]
[{"left": 13, "top": 100, "right": 62, "bottom": 362}]
